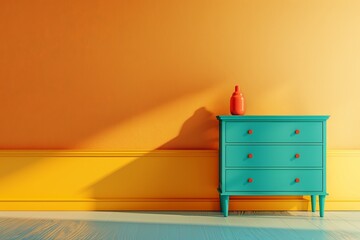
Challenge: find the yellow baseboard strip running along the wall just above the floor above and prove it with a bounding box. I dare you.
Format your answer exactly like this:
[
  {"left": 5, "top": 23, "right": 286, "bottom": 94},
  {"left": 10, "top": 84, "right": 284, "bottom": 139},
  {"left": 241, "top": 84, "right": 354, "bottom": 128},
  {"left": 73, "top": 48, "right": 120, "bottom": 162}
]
[{"left": 0, "top": 198, "right": 360, "bottom": 211}]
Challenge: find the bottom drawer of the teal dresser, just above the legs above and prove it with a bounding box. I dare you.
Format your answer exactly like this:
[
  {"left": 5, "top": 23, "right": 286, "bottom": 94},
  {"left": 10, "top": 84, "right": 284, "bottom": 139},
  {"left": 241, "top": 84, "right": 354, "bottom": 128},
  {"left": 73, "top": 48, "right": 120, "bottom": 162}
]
[{"left": 225, "top": 169, "right": 323, "bottom": 193}]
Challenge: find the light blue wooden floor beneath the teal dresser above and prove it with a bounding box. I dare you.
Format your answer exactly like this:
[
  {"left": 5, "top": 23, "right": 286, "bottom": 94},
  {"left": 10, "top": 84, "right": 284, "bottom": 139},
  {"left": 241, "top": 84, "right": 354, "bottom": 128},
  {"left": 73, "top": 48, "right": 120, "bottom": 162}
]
[{"left": 0, "top": 211, "right": 360, "bottom": 240}]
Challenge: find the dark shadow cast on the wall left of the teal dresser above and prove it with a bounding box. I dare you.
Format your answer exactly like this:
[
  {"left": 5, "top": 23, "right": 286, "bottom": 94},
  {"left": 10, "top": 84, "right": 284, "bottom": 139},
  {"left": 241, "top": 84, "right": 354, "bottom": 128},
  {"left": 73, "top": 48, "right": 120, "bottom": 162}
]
[{"left": 84, "top": 107, "right": 218, "bottom": 205}]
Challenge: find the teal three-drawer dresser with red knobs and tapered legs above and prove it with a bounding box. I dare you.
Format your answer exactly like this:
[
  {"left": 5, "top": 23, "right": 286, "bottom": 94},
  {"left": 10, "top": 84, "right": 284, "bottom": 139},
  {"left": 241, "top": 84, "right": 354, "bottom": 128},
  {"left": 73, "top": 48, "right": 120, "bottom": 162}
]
[{"left": 217, "top": 116, "right": 329, "bottom": 217}]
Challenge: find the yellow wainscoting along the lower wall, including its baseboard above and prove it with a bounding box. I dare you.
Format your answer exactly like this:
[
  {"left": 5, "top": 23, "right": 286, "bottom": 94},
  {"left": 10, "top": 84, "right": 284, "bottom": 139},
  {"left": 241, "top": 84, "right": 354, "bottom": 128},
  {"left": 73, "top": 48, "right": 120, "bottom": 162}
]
[{"left": 0, "top": 150, "right": 360, "bottom": 210}]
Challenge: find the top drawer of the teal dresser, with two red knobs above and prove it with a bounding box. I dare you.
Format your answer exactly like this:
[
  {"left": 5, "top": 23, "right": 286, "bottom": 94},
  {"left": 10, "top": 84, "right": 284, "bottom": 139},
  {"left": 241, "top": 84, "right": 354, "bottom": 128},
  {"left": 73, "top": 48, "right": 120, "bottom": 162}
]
[{"left": 225, "top": 121, "right": 323, "bottom": 143}]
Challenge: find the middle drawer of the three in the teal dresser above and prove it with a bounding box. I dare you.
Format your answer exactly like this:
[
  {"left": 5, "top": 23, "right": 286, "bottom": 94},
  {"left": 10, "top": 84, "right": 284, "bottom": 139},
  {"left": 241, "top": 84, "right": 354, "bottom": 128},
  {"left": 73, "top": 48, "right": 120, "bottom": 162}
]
[{"left": 225, "top": 145, "right": 323, "bottom": 168}]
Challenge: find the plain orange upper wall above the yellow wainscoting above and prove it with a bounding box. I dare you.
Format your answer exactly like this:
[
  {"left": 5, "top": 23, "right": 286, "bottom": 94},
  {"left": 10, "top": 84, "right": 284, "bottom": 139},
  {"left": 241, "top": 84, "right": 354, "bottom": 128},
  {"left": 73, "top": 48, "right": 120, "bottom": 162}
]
[{"left": 0, "top": 0, "right": 360, "bottom": 150}]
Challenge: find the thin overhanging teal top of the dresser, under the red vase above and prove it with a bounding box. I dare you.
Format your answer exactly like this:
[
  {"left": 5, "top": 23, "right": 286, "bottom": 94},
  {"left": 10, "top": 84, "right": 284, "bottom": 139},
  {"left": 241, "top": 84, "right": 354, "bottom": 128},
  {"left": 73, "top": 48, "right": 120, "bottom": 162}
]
[{"left": 216, "top": 115, "right": 330, "bottom": 121}]
